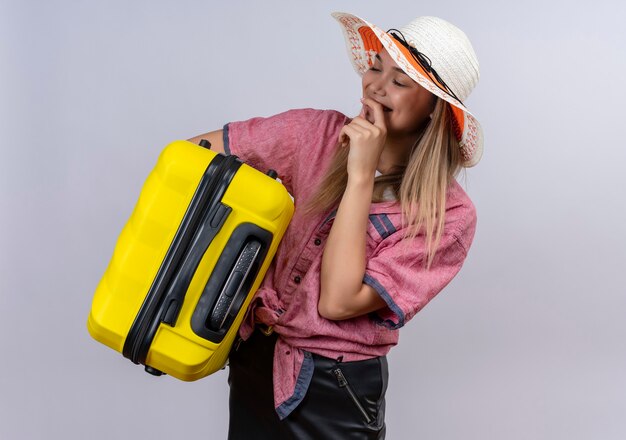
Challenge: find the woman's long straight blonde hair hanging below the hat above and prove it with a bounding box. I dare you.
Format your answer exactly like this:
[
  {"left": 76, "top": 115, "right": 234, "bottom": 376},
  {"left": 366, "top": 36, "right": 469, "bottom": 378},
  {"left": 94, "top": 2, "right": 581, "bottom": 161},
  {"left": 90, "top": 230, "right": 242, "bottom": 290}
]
[{"left": 304, "top": 99, "right": 462, "bottom": 269}]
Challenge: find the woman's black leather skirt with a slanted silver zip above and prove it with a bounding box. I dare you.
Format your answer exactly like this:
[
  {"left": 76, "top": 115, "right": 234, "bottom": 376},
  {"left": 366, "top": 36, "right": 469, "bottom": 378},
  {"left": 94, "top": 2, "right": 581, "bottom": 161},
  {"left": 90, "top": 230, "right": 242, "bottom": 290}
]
[{"left": 228, "top": 330, "right": 388, "bottom": 440}]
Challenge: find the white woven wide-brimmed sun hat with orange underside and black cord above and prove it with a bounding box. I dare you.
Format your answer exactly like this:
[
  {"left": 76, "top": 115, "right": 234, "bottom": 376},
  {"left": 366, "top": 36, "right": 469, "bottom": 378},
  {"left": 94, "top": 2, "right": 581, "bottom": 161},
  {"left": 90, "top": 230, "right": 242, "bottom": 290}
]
[{"left": 332, "top": 12, "right": 483, "bottom": 167}]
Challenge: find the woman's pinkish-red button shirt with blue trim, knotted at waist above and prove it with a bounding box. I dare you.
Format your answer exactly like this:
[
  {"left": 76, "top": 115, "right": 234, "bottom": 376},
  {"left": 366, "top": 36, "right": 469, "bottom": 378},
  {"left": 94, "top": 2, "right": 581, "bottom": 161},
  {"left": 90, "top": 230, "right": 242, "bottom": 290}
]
[{"left": 224, "top": 109, "right": 476, "bottom": 419}]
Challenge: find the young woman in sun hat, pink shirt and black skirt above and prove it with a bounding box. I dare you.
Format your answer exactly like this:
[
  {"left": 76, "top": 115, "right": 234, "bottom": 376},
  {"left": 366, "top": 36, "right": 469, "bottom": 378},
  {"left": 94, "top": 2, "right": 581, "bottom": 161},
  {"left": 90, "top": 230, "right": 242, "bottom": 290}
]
[{"left": 192, "top": 13, "right": 482, "bottom": 439}]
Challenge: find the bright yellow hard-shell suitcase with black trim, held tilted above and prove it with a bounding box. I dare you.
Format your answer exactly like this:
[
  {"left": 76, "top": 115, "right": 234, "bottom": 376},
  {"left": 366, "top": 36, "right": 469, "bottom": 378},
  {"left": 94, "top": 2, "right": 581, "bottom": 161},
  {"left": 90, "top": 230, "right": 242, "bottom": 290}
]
[{"left": 87, "top": 141, "right": 294, "bottom": 381}]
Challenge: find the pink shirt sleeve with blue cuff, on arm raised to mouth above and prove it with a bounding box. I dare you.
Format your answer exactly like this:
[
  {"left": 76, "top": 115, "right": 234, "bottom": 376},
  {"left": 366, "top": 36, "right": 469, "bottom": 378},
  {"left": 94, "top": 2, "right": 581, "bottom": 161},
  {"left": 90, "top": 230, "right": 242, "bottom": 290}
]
[{"left": 363, "top": 211, "right": 475, "bottom": 329}]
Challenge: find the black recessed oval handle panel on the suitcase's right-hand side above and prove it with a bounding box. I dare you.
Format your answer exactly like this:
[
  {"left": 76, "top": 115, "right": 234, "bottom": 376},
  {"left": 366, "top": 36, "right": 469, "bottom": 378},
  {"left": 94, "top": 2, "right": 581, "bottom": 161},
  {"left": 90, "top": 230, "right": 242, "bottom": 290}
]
[{"left": 191, "top": 223, "right": 273, "bottom": 343}]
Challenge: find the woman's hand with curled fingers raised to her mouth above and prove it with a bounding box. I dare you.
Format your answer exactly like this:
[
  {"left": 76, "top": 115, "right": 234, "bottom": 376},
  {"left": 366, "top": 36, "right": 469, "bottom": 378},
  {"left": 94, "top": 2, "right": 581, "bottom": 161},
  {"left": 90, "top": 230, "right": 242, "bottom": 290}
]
[{"left": 339, "top": 98, "right": 387, "bottom": 178}]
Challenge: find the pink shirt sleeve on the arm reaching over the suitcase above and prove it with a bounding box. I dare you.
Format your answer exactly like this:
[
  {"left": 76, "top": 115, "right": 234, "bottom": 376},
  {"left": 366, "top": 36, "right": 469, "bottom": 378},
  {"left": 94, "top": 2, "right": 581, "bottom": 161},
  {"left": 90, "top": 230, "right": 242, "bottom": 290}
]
[{"left": 224, "top": 109, "right": 345, "bottom": 196}]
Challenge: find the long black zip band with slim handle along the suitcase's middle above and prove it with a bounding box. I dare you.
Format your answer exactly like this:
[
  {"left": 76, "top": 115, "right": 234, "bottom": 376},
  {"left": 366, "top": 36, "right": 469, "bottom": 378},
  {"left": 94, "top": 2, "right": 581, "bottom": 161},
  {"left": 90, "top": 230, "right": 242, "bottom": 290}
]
[{"left": 123, "top": 154, "right": 241, "bottom": 374}]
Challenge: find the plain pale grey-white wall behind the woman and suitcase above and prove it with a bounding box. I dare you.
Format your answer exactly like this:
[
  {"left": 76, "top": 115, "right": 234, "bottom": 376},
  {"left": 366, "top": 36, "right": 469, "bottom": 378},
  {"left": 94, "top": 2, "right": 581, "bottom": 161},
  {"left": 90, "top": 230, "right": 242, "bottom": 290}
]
[{"left": 0, "top": 0, "right": 626, "bottom": 440}]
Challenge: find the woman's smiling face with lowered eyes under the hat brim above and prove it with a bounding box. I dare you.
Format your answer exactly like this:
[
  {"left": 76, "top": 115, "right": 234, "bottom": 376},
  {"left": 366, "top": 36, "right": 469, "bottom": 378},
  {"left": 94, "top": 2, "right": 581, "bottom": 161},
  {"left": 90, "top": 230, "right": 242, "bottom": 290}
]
[{"left": 362, "top": 49, "right": 435, "bottom": 136}]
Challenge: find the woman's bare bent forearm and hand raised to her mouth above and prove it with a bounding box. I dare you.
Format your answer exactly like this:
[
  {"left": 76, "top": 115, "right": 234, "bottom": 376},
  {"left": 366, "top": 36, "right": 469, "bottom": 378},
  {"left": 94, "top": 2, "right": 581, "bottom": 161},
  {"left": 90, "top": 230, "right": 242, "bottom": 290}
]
[{"left": 318, "top": 99, "right": 386, "bottom": 320}]
